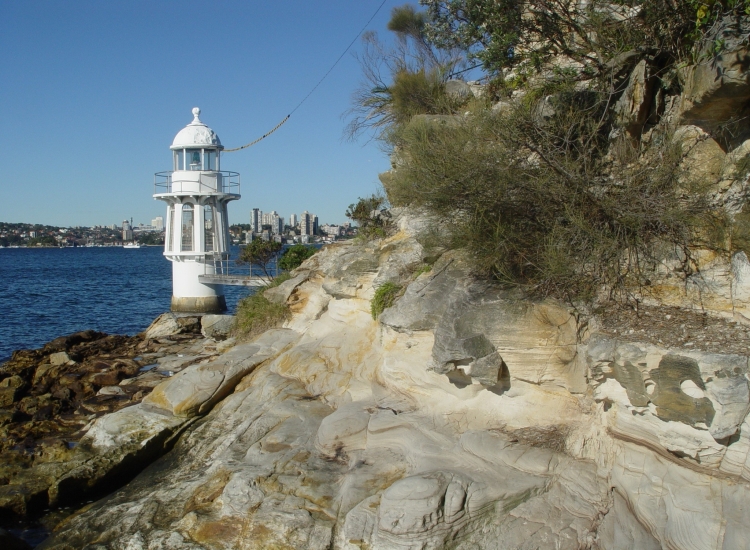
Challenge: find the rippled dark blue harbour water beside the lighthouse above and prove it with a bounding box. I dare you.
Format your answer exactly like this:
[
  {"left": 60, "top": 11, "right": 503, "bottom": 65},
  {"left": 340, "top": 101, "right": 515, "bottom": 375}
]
[{"left": 0, "top": 247, "right": 253, "bottom": 363}]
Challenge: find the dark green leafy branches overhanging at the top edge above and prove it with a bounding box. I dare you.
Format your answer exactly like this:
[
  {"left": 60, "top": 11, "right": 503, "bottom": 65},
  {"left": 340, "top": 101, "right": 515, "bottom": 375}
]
[{"left": 420, "top": 0, "right": 704, "bottom": 76}]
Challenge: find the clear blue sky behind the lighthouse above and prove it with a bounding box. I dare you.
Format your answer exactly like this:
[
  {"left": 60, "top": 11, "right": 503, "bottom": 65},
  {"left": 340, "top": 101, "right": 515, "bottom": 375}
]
[{"left": 0, "top": 0, "right": 405, "bottom": 226}]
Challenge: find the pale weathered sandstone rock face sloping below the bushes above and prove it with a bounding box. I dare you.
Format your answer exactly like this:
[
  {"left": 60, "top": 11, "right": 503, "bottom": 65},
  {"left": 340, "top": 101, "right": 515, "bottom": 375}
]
[{"left": 44, "top": 216, "right": 750, "bottom": 550}]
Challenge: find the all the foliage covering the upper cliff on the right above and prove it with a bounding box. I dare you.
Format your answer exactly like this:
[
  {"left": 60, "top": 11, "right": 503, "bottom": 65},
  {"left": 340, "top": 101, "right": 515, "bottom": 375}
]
[{"left": 347, "top": 0, "right": 750, "bottom": 308}]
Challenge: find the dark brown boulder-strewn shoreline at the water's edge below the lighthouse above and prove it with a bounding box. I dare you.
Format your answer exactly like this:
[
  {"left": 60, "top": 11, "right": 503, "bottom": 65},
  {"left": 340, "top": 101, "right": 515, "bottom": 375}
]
[{"left": 0, "top": 314, "right": 233, "bottom": 547}]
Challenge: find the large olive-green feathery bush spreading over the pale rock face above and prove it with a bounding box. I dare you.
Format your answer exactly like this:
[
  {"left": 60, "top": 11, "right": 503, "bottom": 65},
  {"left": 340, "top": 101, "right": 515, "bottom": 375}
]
[{"left": 384, "top": 94, "right": 726, "bottom": 301}]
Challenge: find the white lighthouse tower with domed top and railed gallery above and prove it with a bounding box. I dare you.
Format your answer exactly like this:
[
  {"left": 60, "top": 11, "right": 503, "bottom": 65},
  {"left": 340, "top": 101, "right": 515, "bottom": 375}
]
[{"left": 154, "top": 107, "right": 240, "bottom": 313}]
